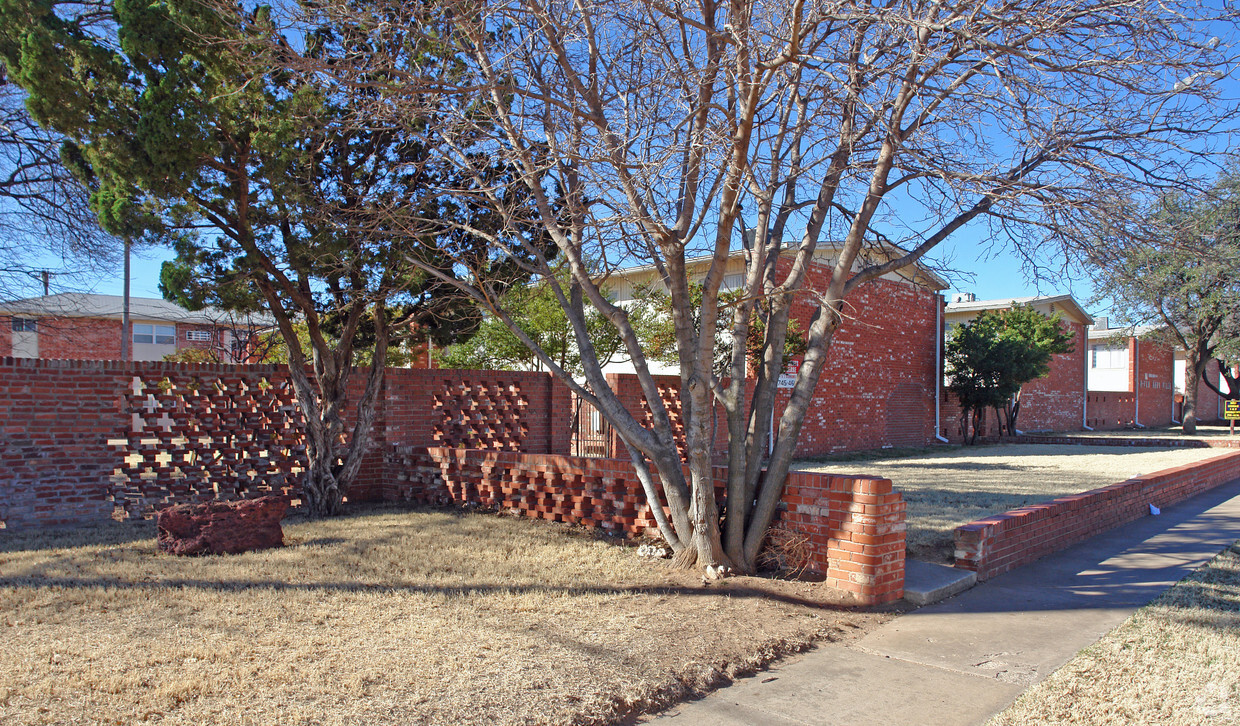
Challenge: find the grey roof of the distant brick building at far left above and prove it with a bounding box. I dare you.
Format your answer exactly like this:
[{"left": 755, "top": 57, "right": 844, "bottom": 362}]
[{"left": 0, "top": 293, "right": 274, "bottom": 325}]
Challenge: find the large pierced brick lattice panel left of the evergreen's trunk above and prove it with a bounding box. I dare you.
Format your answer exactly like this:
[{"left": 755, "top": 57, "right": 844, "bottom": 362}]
[{"left": 109, "top": 372, "right": 306, "bottom": 516}]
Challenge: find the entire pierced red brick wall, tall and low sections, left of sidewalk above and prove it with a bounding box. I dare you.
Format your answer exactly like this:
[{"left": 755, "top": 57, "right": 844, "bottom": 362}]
[{"left": 0, "top": 359, "right": 905, "bottom": 604}]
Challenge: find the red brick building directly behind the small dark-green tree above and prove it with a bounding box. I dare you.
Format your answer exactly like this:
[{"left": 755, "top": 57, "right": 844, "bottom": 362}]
[{"left": 940, "top": 295, "right": 1094, "bottom": 441}]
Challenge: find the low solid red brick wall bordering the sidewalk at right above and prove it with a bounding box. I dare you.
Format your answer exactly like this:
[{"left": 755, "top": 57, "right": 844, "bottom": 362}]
[{"left": 954, "top": 452, "right": 1240, "bottom": 580}]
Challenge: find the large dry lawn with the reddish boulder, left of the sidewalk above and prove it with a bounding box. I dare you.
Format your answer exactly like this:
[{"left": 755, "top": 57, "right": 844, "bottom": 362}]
[{"left": 0, "top": 509, "right": 889, "bottom": 725}]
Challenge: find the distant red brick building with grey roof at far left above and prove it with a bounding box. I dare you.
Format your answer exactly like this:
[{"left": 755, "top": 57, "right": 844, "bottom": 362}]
[{"left": 0, "top": 293, "right": 270, "bottom": 362}]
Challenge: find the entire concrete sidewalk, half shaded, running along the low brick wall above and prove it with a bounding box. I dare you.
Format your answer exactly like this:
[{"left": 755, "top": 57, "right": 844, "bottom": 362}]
[{"left": 651, "top": 480, "right": 1240, "bottom": 726}]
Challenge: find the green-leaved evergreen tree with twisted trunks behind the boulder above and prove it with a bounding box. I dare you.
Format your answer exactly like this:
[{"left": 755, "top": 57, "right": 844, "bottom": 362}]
[{"left": 0, "top": 0, "right": 537, "bottom": 515}]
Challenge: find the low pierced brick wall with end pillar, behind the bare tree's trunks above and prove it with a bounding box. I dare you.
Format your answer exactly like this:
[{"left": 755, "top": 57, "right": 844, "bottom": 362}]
[{"left": 372, "top": 447, "right": 905, "bottom": 604}]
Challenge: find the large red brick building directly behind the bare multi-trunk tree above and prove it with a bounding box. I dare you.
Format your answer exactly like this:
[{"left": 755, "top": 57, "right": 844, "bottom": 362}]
[{"left": 605, "top": 248, "right": 947, "bottom": 455}]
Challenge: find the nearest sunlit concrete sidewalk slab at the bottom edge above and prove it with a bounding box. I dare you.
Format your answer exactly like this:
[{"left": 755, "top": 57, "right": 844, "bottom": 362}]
[{"left": 660, "top": 645, "right": 1024, "bottom": 726}]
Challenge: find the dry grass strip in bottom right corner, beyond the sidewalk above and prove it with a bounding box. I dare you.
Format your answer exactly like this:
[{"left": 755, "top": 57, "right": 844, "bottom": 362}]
[{"left": 990, "top": 542, "right": 1240, "bottom": 726}]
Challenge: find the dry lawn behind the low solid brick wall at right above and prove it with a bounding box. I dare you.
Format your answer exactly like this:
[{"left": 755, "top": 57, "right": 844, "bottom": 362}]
[{"left": 795, "top": 444, "right": 1228, "bottom": 562}]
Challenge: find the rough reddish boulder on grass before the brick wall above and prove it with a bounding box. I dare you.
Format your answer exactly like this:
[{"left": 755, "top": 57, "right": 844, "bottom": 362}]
[{"left": 155, "top": 496, "right": 289, "bottom": 555}]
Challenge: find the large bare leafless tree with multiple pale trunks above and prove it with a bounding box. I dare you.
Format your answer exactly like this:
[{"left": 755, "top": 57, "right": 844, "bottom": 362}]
[{"left": 312, "top": 0, "right": 1230, "bottom": 571}]
